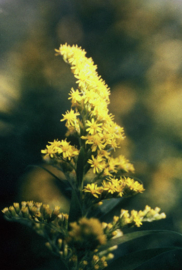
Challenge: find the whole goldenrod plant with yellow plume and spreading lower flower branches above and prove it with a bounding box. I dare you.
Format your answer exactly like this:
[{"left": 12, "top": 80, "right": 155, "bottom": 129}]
[{"left": 2, "top": 44, "right": 175, "bottom": 270}]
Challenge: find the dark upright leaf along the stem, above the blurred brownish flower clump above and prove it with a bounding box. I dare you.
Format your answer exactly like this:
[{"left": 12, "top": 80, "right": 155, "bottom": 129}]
[{"left": 69, "top": 189, "right": 82, "bottom": 223}]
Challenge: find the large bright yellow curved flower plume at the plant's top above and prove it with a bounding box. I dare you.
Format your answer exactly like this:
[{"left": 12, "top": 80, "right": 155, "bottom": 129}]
[{"left": 56, "top": 44, "right": 127, "bottom": 176}]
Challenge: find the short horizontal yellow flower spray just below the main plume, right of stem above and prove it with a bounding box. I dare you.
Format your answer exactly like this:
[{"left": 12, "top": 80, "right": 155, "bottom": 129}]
[{"left": 83, "top": 177, "right": 144, "bottom": 201}]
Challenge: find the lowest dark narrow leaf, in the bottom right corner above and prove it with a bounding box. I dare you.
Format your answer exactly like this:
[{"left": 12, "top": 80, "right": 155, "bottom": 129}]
[{"left": 110, "top": 247, "right": 179, "bottom": 270}]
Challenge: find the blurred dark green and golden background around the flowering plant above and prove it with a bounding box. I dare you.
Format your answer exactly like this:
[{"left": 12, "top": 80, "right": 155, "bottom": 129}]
[{"left": 0, "top": 0, "right": 182, "bottom": 270}]
